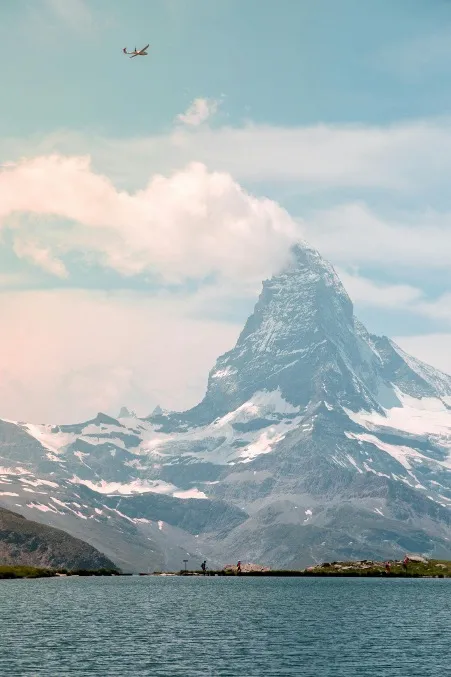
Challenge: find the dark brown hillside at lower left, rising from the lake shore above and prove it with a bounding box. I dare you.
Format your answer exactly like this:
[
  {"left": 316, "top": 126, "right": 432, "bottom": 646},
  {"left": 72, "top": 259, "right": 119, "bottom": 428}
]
[{"left": 0, "top": 508, "right": 116, "bottom": 570}]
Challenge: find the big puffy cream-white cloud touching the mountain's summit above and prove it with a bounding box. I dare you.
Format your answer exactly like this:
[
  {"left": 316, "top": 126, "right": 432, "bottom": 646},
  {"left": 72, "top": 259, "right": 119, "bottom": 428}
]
[{"left": 0, "top": 156, "right": 299, "bottom": 283}]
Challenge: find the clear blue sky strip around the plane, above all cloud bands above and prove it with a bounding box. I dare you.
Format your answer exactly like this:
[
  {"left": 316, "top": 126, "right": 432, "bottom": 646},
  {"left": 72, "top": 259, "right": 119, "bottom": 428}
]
[{"left": 0, "top": 0, "right": 451, "bottom": 136}]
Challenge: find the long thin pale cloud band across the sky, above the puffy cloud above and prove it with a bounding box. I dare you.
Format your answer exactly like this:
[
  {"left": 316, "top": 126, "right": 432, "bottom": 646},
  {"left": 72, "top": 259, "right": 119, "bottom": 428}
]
[{"left": 6, "top": 119, "right": 451, "bottom": 195}]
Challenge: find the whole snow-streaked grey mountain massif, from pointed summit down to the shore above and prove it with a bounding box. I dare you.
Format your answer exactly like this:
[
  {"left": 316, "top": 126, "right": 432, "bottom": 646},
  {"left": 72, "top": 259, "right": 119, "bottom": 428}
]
[{"left": 0, "top": 245, "right": 451, "bottom": 570}]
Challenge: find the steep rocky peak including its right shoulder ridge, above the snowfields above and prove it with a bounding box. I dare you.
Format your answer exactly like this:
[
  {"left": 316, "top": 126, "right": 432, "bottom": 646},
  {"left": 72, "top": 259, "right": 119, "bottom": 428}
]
[{"left": 168, "top": 239, "right": 451, "bottom": 425}]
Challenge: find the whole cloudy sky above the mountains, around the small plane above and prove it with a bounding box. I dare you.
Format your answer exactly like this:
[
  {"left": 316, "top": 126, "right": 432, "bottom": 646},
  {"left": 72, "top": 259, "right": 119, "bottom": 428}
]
[{"left": 0, "top": 0, "right": 451, "bottom": 423}]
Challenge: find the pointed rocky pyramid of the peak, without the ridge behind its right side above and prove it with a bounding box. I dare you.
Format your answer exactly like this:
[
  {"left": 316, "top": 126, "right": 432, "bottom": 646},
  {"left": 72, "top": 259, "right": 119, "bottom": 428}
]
[{"left": 182, "top": 244, "right": 378, "bottom": 420}]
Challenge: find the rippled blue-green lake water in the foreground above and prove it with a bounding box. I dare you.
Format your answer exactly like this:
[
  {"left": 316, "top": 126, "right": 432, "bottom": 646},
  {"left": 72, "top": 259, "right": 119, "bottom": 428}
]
[{"left": 0, "top": 577, "right": 451, "bottom": 677}]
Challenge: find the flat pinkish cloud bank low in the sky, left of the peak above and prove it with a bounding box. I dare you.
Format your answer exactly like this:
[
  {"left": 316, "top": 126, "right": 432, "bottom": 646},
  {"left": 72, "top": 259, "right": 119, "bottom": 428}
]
[{"left": 0, "top": 290, "right": 241, "bottom": 422}]
